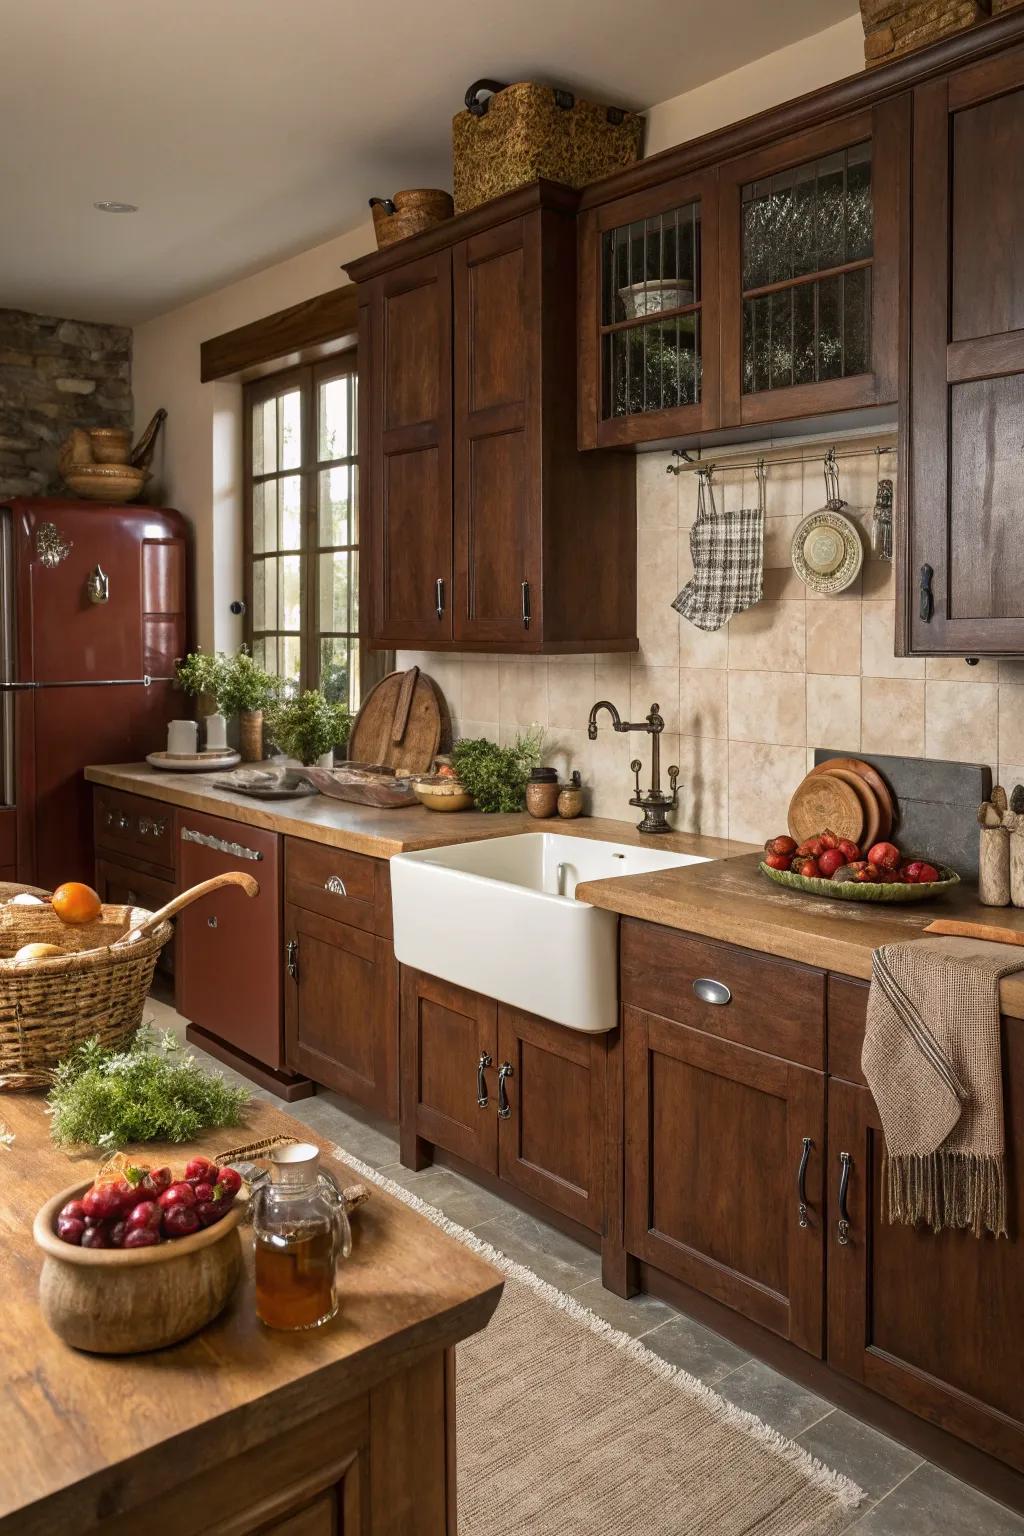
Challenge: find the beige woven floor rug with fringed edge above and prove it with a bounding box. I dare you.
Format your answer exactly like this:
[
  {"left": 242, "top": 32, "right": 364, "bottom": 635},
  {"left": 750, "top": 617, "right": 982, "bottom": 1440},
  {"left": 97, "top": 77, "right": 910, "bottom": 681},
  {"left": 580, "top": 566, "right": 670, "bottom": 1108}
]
[{"left": 336, "top": 1147, "right": 864, "bottom": 1536}]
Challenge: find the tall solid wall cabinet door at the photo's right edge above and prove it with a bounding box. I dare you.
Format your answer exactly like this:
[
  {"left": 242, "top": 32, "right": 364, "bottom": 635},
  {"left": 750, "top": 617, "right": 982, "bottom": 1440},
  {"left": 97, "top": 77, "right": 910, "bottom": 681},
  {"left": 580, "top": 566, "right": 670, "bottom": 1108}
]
[{"left": 900, "top": 48, "right": 1024, "bottom": 656}]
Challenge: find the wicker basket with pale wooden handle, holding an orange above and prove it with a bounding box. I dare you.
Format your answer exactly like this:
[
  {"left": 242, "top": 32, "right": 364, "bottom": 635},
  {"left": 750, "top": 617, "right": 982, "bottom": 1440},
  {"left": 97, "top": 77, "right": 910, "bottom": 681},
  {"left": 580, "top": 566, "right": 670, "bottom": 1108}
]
[{"left": 0, "top": 871, "right": 259, "bottom": 1092}]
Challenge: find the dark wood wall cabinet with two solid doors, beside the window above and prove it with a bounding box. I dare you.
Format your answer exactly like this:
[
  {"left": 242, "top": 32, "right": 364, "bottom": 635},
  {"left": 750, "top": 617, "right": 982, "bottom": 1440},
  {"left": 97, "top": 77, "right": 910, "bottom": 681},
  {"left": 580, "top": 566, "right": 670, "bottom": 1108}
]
[{"left": 347, "top": 181, "right": 637, "bottom": 653}]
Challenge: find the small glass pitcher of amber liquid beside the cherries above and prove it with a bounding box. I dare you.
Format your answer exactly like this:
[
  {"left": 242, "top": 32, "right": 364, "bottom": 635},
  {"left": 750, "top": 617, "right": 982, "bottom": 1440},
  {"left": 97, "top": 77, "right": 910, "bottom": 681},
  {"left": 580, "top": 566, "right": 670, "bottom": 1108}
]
[{"left": 252, "top": 1143, "right": 352, "bottom": 1330}]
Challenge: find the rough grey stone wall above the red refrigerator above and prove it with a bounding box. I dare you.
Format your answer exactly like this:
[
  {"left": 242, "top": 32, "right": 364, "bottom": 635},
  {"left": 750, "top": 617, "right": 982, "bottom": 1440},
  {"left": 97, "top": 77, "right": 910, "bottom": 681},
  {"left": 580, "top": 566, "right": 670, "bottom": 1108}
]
[{"left": 0, "top": 309, "right": 132, "bottom": 498}]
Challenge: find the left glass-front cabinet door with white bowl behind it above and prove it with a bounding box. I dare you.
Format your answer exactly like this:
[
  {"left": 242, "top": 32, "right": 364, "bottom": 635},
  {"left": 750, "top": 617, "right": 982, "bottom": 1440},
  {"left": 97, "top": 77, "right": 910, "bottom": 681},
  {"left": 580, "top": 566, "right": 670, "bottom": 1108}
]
[{"left": 579, "top": 172, "right": 718, "bottom": 447}]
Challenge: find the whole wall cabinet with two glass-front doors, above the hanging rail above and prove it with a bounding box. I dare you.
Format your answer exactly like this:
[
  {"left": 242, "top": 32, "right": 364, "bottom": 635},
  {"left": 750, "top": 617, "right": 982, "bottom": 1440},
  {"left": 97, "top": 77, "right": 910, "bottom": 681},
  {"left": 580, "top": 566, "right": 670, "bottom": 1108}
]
[{"left": 579, "top": 97, "right": 910, "bottom": 447}]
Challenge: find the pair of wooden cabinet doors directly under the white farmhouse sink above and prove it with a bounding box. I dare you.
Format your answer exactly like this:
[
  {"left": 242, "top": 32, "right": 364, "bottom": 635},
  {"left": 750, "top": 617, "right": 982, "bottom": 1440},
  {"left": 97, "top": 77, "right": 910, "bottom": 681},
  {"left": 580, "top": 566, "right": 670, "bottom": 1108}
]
[{"left": 401, "top": 966, "right": 608, "bottom": 1232}]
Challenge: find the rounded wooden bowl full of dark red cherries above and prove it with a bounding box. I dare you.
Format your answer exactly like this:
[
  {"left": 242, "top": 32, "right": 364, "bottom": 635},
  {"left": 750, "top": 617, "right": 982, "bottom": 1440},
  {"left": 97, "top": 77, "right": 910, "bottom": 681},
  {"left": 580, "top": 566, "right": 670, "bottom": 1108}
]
[{"left": 32, "top": 1154, "right": 247, "bottom": 1355}]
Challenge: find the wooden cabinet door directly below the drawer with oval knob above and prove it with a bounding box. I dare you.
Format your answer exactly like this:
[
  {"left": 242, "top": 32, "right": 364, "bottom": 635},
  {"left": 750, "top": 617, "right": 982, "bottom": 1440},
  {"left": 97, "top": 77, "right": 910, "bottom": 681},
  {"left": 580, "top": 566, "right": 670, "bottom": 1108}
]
[{"left": 623, "top": 1008, "right": 824, "bottom": 1356}]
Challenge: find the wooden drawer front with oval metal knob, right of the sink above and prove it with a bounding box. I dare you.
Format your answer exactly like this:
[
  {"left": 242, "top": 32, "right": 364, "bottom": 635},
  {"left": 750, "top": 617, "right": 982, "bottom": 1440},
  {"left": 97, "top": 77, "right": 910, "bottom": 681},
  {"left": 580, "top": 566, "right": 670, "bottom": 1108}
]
[{"left": 622, "top": 919, "right": 824, "bottom": 1071}]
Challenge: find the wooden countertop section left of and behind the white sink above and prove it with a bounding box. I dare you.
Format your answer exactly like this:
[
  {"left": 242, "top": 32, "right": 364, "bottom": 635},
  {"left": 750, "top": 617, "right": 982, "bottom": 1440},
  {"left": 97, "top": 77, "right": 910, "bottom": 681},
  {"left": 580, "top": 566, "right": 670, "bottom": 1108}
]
[{"left": 86, "top": 763, "right": 751, "bottom": 859}]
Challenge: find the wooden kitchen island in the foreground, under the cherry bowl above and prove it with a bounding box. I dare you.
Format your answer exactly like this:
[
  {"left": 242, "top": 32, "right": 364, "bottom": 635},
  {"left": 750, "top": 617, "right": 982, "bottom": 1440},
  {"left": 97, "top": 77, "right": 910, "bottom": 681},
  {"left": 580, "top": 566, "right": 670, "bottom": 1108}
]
[{"left": 0, "top": 1094, "right": 502, "bottom": 1536}]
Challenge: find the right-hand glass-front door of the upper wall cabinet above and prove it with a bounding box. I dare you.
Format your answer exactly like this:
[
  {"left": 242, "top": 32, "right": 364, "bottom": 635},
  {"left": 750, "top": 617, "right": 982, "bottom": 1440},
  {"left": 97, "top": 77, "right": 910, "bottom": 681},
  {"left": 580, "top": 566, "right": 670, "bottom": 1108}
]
[{"left": 720, "top": 101, "right": 907, "bottom": 427}]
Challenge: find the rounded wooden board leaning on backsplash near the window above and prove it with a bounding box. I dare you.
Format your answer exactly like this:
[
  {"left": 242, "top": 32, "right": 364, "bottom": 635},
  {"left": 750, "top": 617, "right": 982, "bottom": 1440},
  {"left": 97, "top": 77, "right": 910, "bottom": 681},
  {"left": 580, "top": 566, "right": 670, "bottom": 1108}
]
[{"left": 347, "top": 667, "right": 451, "bottom": 773}]
